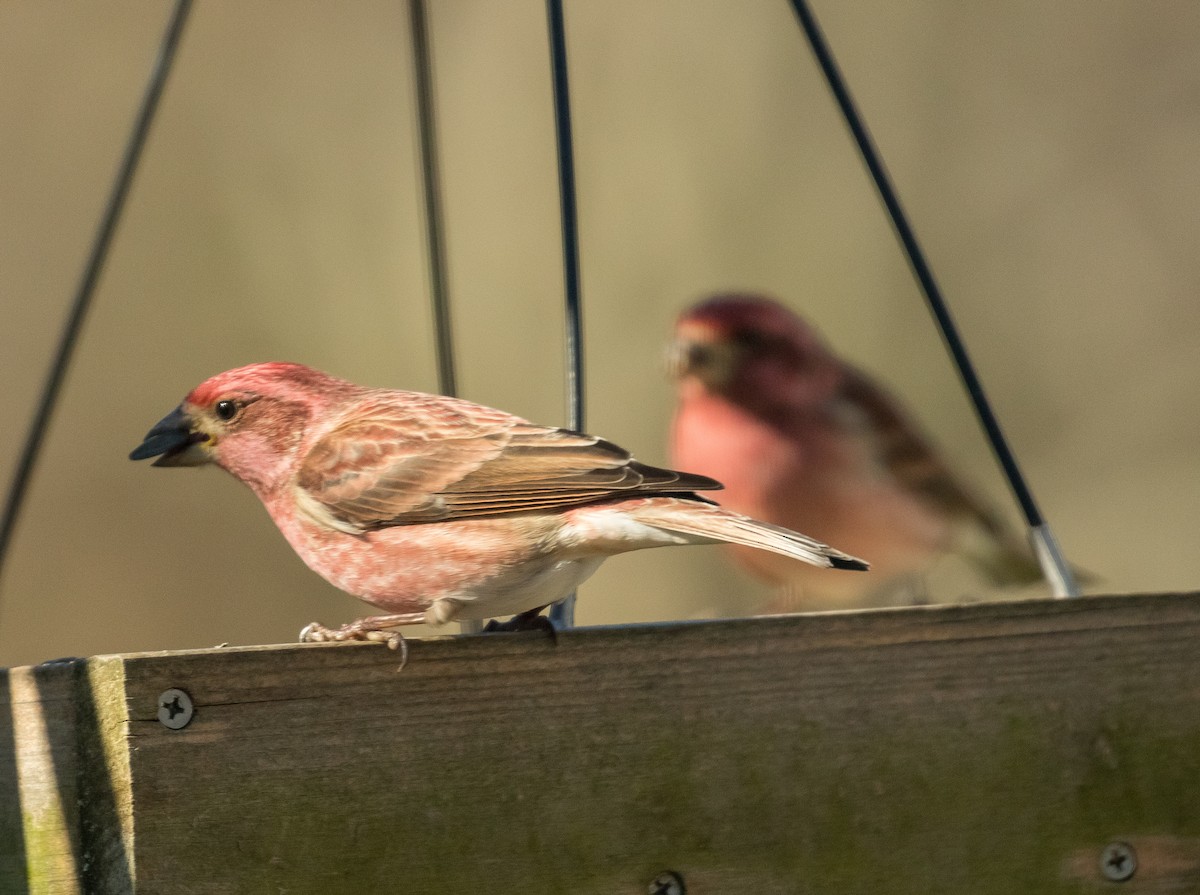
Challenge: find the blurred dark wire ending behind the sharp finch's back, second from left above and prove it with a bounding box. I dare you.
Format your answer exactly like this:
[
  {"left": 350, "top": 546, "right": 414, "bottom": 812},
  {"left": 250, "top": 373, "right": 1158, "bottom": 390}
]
[{"left": 408, "top": 0, "right": 458, "bottom": 395}]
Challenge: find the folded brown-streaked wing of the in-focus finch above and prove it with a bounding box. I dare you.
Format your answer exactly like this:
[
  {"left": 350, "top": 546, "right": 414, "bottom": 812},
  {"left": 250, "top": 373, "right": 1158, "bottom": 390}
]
[{"left": 296, "top": 388, "right": 720, "bottom": 530}]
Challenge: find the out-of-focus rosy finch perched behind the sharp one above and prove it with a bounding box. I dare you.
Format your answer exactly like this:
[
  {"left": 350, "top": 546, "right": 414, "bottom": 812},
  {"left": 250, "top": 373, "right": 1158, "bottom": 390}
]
[{"left": 671, "top": 295, "right": 1040, "bottom": 611}]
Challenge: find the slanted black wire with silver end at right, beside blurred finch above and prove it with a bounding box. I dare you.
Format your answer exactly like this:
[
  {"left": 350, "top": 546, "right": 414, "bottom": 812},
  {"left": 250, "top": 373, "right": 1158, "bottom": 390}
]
[{"left": 791, "top": 0, "right": 1079, "bottom": 596}]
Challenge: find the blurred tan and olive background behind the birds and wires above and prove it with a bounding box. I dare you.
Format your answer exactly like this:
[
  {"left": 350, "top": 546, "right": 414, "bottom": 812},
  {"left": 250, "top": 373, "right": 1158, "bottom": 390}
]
[{"left": 0, "top": 0, "right": 1200, "bottom": 665}]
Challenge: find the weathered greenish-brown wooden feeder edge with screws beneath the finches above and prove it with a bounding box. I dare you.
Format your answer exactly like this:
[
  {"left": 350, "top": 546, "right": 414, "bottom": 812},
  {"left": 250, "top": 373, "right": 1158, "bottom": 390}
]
[{"left": 0, "top": 595, "right": 1200, "bottom": 895}]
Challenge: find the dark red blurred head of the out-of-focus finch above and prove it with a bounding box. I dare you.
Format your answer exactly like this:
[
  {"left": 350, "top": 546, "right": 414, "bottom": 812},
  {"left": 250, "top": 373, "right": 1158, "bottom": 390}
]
[{"left": 668, "top": 294, "right": 841, "bottom": 413}]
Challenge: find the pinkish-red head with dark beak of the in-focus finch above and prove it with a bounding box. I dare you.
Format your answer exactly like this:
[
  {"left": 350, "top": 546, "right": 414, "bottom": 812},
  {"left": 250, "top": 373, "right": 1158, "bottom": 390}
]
[{"left": 130, "top": 364, "right": 356, "bottom": 492}]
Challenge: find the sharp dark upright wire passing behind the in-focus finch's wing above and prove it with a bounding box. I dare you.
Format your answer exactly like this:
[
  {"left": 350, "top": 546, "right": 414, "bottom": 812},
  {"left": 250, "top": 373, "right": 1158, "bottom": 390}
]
[{"left": 546, "top": 0, "right": 584, "bottom": 627}]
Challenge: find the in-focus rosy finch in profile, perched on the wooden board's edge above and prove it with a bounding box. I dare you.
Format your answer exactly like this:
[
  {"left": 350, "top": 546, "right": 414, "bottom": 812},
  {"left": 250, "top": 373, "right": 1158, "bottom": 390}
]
[{"left": 130, "top": 364, "right": 866, "bottom": 639}]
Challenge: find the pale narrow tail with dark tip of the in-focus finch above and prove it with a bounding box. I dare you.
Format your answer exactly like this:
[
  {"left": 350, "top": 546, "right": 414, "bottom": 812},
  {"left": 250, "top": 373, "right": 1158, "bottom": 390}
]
[{"left": 636, "top": 500, "right": 868, "bottom": 571}]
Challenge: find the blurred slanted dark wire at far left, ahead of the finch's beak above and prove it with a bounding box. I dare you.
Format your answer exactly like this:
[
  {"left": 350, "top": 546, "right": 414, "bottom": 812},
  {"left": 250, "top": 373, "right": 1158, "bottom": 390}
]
[{"left": 0, "top": 0, "right": 192, "bottom": 592}]
